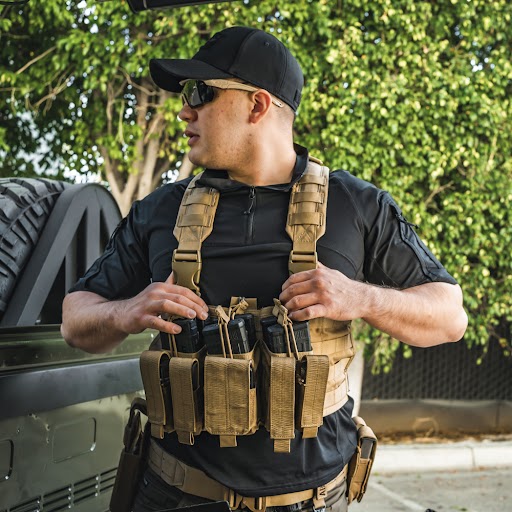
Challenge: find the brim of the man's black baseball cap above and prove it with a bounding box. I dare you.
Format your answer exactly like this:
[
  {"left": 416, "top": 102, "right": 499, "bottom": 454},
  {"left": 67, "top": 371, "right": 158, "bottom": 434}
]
[{"left": 149, "top": 59, "right": 232, "bottom": 92}]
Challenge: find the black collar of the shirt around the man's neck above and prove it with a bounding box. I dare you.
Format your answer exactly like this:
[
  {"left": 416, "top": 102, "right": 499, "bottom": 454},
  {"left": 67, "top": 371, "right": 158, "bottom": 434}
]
[{"left": 197, "top": 144, "right": 309, "bottom": 192}]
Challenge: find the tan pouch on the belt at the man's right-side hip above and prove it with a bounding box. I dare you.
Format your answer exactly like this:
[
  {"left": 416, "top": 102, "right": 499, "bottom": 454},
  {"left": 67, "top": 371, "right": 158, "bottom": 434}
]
[{"left": 347, "top": 416, "right": 377, "bottom": 504}]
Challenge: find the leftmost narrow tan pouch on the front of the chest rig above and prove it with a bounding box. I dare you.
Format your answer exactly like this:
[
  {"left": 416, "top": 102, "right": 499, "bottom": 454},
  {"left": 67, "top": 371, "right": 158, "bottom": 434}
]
[{"left": 140, "top": 350, "right": 172, "bottom": 439}]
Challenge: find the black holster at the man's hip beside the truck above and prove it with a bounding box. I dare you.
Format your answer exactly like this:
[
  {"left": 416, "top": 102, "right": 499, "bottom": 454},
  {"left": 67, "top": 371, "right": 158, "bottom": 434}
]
[{"left": 109, "top": 398, "right": 151, "bottom": 512}]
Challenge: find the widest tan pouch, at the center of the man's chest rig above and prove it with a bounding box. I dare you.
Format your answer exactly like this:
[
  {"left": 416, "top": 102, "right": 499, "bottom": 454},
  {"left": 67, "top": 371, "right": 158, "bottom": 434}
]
[{"left": 204, "top": 351, "right": 258, "bottom": 447}]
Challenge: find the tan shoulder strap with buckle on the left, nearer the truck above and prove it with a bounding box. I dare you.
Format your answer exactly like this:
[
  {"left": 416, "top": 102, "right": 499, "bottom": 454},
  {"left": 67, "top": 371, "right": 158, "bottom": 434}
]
[{"left": 172, "top": 173, "right": 219, "bottom": 295}]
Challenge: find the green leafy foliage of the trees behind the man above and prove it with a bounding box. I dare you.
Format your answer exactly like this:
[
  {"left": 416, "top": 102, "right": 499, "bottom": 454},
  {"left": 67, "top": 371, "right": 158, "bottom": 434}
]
[{"left": 0, "top": 0, "right": 512, "bottom": 369}]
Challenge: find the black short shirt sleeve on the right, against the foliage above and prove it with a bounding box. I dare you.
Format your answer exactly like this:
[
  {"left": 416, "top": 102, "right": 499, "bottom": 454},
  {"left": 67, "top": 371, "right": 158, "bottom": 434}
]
[{"left": 364, "top": 189, "right": 457, "bottom": 289}]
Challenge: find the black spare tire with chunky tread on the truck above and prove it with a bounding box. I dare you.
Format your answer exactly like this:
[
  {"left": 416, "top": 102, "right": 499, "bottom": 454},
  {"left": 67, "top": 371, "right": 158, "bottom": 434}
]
[{"left": 0, "top": 178, "right": 68, "bottom": 318}]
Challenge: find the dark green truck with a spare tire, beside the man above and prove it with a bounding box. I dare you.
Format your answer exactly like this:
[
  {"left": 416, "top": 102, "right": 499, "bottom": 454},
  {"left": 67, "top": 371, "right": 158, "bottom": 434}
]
[{"left": 0, "top": 178, "right": 151, "bottom": 512}]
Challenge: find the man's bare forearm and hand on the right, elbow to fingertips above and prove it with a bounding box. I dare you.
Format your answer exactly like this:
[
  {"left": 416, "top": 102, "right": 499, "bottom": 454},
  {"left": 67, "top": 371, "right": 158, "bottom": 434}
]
[{"left": 279, "top": 264, "right": 467, "bottom": 347}]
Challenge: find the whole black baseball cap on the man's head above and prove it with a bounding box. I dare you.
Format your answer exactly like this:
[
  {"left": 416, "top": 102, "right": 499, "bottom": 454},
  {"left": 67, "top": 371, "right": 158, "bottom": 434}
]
[{"left": 149, "top": 27, "right": 304, "bottom": 111}]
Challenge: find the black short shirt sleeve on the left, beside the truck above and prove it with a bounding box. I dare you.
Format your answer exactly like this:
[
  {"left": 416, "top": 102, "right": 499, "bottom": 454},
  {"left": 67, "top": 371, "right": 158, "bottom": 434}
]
[{"left": 69, "top": 202, "right": 151, "bottom": 300}]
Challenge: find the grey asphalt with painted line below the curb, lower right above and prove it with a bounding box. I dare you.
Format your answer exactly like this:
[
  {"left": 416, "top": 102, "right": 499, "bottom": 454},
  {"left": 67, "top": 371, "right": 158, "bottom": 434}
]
[{"left": 349, "top": 468, "right": 512, "bottom": 512}]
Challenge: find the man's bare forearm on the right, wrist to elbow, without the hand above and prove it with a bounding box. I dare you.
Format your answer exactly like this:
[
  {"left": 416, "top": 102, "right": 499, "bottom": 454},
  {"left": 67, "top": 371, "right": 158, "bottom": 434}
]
[{"left": 362, "top": 283, "right": 467, "bottom": 347}]
